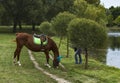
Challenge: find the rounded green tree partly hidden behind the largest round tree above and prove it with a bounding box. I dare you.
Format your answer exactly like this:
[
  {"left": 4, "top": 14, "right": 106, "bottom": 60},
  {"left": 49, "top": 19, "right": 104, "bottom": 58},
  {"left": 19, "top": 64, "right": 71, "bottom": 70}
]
[{"left": 51, "top": 12, "right": 76, "bottom": 57}]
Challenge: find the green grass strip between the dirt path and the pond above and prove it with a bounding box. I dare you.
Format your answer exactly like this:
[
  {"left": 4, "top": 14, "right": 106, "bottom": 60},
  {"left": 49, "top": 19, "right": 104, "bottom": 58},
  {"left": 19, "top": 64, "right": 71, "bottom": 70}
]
[{"left": 34, "top": 38, "right": 120, "bottom": 83}]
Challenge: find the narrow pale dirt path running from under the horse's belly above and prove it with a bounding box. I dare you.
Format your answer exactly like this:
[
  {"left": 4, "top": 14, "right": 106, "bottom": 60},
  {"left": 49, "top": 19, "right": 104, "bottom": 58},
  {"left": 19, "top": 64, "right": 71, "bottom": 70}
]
[{"left": 28, "top": 50, "right": 71, "bottom": 83}]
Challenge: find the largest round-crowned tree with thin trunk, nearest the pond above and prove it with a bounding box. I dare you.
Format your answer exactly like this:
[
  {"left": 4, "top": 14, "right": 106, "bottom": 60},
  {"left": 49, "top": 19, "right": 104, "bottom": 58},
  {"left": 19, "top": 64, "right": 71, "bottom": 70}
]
[{"left": 68, "top": 18, "right": 107, "bottom": 68}]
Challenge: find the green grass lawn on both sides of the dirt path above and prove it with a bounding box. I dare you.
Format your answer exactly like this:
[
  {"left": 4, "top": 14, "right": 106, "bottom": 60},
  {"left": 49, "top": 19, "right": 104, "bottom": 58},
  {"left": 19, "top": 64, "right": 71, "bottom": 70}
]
[{"left": 0, "top": 26, "right": 120, "bottom": 83}]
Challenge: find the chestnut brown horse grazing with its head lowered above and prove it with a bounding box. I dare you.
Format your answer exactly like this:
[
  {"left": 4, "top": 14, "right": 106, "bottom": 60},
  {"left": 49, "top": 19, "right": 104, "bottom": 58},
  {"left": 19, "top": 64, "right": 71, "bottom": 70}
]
[{"left": 14, "top": 33, "right": 59, "bottom": 68}]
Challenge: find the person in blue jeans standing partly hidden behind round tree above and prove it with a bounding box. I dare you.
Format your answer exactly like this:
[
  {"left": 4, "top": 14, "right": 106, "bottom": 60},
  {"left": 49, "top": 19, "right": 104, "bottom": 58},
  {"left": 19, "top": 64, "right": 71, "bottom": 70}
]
[{"left": 74, "top": 47, "right": 82, "bottom": 64}]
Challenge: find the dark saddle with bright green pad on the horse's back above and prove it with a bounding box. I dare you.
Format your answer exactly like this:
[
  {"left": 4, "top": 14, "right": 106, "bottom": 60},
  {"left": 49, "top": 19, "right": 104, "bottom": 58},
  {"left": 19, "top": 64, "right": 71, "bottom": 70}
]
[{"left": 33, "top": 33, "right": 48, "bottom": 46}]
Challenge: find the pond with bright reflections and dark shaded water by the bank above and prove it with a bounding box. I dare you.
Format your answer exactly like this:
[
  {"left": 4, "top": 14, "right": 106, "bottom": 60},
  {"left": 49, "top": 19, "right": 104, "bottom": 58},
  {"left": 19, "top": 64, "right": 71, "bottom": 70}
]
[{"left": 90, "top": 32, "right": 120, "bottom": 68}]
